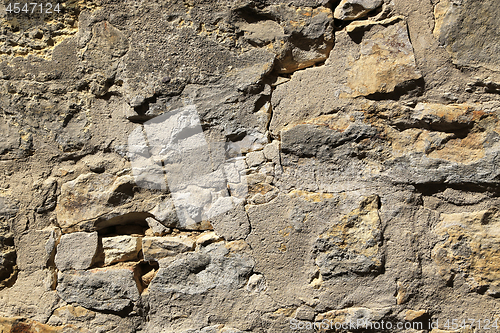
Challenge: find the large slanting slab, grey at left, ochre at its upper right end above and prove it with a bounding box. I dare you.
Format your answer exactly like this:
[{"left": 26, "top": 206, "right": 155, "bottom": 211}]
[{"left": 270, "top": 22, "right": 422, "bottom": 135}]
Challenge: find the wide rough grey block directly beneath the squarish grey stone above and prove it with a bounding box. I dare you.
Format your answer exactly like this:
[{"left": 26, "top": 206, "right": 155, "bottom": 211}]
[{"left": 57, "top": 269, "right": 140, "bottom": 312}]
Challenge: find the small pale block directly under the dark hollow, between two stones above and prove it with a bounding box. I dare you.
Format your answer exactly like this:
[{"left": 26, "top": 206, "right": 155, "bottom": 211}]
[{"left": 102, "top": 235, "right": 142, "bottom": 265}]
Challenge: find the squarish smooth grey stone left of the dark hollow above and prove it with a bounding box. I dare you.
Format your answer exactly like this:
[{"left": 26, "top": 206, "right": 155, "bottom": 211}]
[{"left": 55, "top": 232, "right": 99, "bottom": 271}]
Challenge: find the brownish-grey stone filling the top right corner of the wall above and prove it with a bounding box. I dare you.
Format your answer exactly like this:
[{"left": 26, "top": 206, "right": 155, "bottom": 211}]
[{"left": 434, "top": 0, "right": 500, "bottom": 71}]
